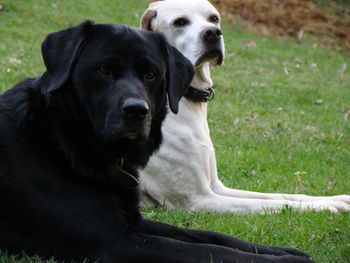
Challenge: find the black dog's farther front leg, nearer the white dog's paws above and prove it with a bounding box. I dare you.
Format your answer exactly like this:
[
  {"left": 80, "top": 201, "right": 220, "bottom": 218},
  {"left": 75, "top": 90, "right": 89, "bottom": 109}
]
[{"left": 140, "top": 219, "right": 311, "bottom": 262}]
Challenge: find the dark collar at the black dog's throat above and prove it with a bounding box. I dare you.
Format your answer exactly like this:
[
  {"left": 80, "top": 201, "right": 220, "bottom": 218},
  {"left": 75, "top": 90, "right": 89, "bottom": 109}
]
[{"left": 106, "top": 158, "right": 139, "bottom": 188}]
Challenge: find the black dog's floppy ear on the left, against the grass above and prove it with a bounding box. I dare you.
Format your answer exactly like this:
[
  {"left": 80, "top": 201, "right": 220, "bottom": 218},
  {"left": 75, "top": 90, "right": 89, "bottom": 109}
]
[{"left": 41, "top": 20, "right": 94, "bottom": 92}]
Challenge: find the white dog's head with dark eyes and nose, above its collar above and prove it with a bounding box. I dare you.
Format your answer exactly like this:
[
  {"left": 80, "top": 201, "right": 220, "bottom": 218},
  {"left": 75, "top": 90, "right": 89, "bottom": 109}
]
[{"left": 141, "top": 0, "right": 224, "bottom": 89}]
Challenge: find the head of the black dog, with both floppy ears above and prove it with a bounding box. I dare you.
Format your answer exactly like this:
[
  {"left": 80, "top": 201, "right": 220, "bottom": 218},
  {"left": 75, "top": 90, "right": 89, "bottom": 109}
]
[{"left": 42, "top": 21, "right": 193, "bottom": 148}]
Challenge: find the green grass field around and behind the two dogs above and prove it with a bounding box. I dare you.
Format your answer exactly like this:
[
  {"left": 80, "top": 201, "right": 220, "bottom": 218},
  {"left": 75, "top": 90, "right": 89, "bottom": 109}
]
[{"left": 0, "top": 0, "right": 350, "bottom": 263}]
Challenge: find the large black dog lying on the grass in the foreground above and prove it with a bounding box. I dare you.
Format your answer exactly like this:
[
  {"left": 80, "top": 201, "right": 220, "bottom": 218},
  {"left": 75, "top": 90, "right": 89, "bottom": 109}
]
[{"left": 0, "top": 22, "right": 312, "bottom": 263}]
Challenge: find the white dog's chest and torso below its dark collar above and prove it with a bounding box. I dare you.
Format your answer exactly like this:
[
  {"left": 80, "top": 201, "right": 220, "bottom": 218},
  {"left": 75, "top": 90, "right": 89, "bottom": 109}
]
[{"left": 141, "top": 99, "right": 216, "bottom": 207}]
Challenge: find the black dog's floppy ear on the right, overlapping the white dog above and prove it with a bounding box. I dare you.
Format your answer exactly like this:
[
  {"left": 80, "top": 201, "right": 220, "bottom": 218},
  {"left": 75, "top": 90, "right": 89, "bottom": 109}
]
[{"left": 166, "top": 43, "right": 194, "bottom": 114}]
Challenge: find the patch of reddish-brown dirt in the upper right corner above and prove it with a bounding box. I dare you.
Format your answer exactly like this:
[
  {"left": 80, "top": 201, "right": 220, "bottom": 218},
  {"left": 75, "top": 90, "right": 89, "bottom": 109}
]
[{"left": 210, "top": 0, "right": 350, "bottom": 50}]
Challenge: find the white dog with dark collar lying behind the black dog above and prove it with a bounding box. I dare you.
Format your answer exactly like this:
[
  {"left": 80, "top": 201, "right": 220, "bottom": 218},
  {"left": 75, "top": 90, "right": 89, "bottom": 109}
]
[{"left": 141, "top": 0, "right": 350, "bottom": 212}]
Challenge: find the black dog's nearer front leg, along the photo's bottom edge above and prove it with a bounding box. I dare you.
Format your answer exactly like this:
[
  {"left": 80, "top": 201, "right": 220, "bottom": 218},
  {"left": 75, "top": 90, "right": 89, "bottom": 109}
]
[{"left": 110, "top": 232, "right": 312, "bottom": 263}]
